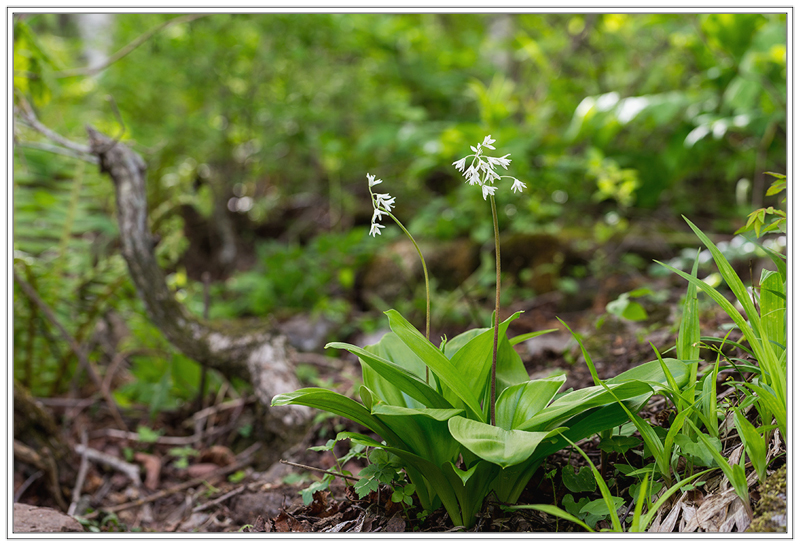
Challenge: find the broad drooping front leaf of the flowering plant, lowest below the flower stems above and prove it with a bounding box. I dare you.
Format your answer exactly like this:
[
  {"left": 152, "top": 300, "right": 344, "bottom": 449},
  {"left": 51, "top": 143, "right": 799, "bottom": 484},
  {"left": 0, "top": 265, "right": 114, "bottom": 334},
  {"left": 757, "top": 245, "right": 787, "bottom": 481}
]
[{"left": 448, "top": 417, "right": 563, "bottom": 468}]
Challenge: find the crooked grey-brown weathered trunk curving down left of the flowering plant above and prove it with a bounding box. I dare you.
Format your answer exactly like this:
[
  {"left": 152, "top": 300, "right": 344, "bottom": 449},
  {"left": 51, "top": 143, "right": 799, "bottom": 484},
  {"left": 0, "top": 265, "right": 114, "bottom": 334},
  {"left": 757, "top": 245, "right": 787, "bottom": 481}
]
[{"left": 87, "top": 127, "right": 311, "bottom": 465}]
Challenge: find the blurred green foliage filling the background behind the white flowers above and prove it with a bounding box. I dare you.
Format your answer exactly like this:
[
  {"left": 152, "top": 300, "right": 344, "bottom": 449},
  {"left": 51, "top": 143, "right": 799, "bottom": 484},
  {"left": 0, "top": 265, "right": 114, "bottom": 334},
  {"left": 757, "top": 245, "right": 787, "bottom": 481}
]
[{"left": 13, "top": 13, "right": 786, "bottom": 404}]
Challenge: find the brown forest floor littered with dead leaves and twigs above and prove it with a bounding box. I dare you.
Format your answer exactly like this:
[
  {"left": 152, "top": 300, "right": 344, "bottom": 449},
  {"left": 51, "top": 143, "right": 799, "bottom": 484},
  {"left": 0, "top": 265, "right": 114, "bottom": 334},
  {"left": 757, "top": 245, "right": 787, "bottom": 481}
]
[{"left": 14, "top": 274, "right": 785, "bottom": 533}]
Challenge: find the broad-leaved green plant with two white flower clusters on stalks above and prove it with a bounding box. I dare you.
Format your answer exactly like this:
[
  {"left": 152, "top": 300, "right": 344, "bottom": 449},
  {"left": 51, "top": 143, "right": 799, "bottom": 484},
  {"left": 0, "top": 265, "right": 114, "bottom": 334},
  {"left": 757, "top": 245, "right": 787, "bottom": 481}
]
[{"left": 272, "top": 136, "right": 688, "bottom": 528}]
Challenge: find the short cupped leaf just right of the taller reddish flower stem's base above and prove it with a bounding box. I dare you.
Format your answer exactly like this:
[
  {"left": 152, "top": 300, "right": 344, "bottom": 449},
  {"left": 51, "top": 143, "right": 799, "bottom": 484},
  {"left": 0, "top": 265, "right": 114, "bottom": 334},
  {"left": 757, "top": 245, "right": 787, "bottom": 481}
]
[{"left": 495, "top": 375, "right": 567, "bottom": 430}]
